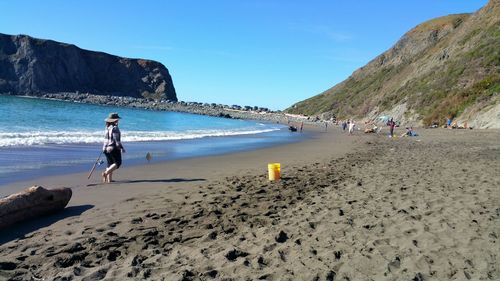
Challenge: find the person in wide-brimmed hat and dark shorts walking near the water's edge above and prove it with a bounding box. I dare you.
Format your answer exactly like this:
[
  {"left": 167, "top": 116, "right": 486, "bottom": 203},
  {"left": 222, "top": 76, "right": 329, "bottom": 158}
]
[{"left": 102, "top": 113, "right": 125, "bottom": 183}]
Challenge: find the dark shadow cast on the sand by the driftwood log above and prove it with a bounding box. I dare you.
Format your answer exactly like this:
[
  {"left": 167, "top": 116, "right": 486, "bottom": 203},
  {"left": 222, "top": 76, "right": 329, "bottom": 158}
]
[{"left": 0, "top": 205, "right": 94, "bottom": 245}]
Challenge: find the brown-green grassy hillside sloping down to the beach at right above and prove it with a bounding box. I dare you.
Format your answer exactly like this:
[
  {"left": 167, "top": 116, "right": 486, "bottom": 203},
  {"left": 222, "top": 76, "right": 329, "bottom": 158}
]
[{"left": 287, "top": 0, "right": 500, "bottom": 127}]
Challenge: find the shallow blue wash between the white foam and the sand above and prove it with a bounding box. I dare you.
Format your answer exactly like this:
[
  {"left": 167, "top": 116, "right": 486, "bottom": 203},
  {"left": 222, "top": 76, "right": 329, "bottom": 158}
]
[{"left": 0, "top": 125, "right": 312, "bottom": 187}]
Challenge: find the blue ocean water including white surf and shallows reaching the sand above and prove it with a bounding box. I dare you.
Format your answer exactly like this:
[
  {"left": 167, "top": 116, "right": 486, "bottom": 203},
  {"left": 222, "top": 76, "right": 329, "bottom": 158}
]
[{"left": 0, "top": 95, "right": 301, "bottom": 185}]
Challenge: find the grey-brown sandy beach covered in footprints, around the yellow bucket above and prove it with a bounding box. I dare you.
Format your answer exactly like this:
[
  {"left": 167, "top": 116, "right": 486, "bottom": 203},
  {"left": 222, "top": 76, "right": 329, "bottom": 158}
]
[{"left": 0, "top": 129, "right": 500, "bottom": 280}]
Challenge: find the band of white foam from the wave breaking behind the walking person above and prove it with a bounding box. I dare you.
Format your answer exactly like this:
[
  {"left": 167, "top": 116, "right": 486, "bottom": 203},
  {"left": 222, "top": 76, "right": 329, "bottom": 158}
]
[{"left": 0, "top": 128, "right": 279, "bottom": 147}]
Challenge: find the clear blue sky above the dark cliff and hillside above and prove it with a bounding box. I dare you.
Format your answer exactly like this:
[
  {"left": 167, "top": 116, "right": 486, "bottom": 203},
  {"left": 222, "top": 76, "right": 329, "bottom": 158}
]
[{"left": 0, "top": 0, "right": 487, "bottom": 109}]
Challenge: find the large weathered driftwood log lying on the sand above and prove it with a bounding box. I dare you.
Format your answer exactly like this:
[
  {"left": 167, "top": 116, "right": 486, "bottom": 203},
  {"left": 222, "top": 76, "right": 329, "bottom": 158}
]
[{"left": 0, "top": 186, "right": 72, "bottom": 229}]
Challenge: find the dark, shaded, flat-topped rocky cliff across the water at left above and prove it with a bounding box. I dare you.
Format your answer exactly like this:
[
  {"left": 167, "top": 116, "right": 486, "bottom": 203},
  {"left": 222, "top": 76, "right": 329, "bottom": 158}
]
[{"left": 0, "top": 34, "right": 177, "bottom": 101}]
